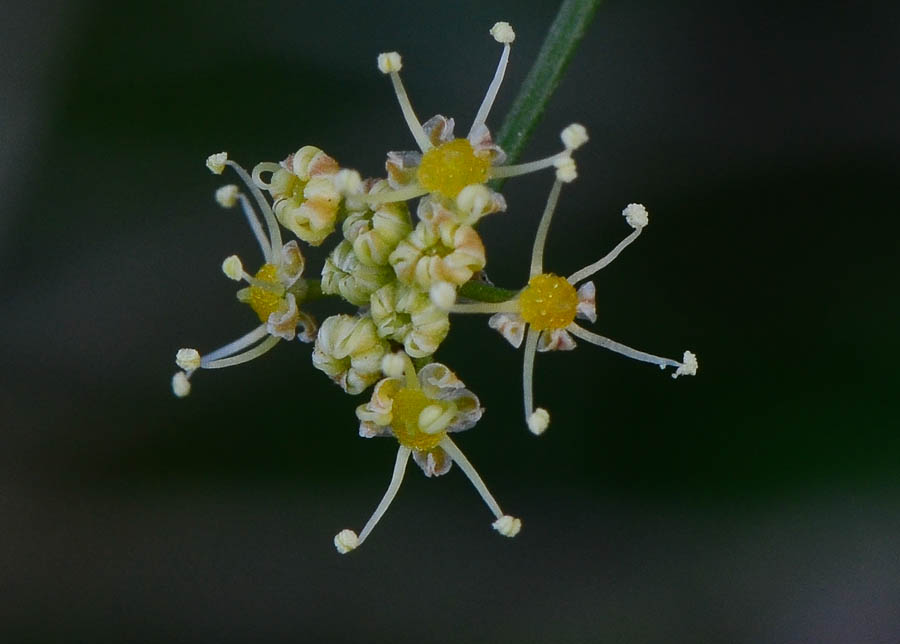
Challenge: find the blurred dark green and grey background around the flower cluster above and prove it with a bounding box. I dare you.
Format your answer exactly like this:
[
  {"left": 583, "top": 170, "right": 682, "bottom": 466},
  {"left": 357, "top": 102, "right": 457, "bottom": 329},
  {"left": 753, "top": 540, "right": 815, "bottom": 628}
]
[{"left": 0, "top": 0, "right": 900, "bottom": 643}]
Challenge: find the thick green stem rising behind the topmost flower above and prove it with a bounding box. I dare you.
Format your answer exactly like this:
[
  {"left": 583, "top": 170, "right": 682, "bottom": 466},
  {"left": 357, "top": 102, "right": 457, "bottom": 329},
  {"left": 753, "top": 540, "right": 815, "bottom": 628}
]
[{"left": 494, "top": 0, "right": 600, "bottom": 181}]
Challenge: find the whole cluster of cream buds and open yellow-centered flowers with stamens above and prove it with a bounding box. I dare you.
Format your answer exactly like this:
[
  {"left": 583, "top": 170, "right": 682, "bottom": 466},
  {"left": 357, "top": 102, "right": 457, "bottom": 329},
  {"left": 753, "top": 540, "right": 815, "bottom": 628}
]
[{"left": 172, "top": 22, "right": 697, "bottom": 553}]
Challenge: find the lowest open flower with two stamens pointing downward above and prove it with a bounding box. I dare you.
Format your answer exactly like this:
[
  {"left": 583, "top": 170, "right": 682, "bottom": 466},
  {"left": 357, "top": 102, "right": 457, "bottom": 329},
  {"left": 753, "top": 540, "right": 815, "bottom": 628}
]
[{"left": 334, "top": 354, "right": 522, "bottom": 554}]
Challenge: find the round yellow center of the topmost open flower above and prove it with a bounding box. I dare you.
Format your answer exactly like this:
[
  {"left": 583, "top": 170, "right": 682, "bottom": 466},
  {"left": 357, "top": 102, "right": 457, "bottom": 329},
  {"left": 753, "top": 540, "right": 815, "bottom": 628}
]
[{"left": 416, "top": 139, "right": 491, "bottom": 199}]
